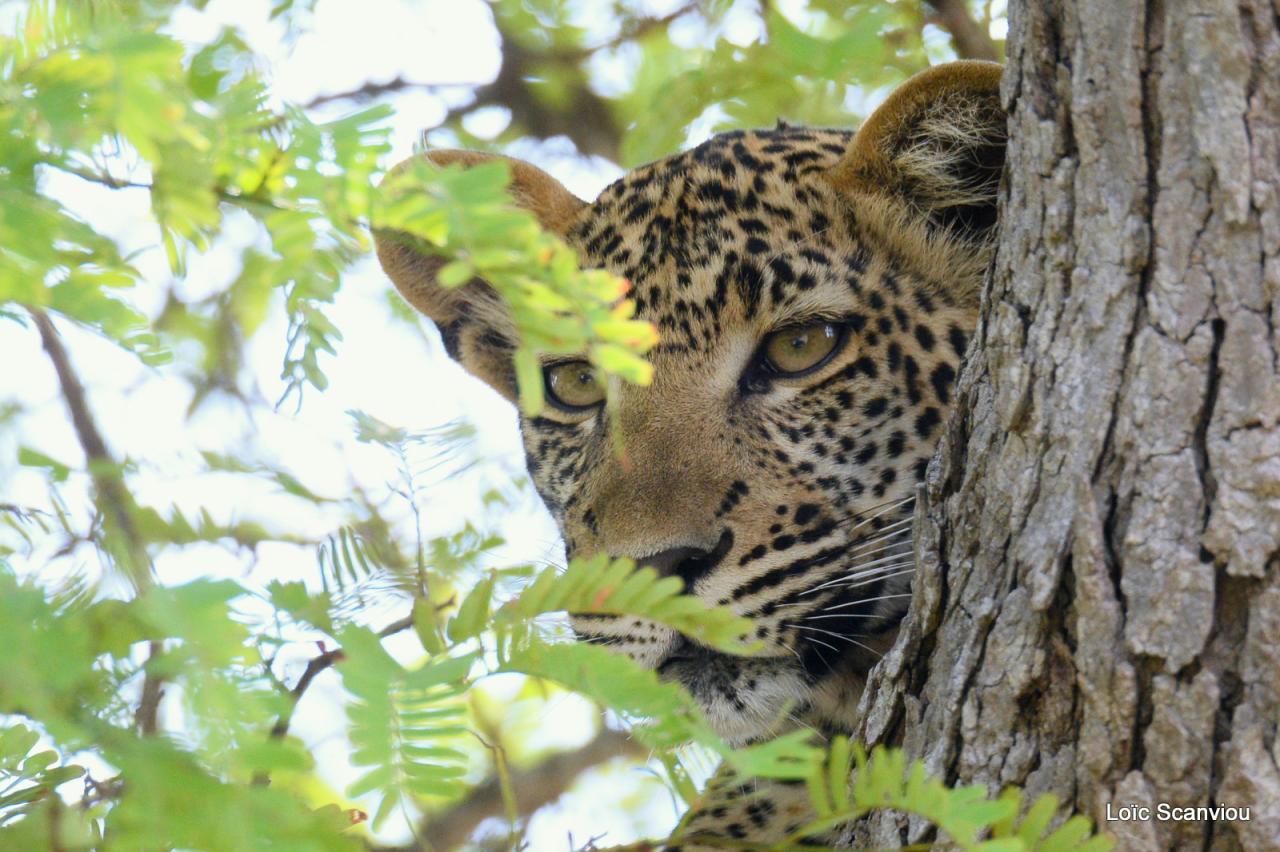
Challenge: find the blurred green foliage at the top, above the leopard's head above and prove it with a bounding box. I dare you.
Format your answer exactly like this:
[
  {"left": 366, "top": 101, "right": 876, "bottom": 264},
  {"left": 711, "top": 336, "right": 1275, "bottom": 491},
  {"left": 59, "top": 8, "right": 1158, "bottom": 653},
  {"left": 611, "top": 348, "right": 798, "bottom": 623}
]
[{"left": 435, "top": 0, "right": 1005, "bottom": 166}]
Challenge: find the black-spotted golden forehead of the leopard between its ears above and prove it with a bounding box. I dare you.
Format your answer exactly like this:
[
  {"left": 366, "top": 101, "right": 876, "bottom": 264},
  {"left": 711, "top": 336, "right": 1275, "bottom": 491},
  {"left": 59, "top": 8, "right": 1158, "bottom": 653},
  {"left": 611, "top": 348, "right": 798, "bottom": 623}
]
[{"left": 570, "top": 127, "right": 867, "bottom": 332}]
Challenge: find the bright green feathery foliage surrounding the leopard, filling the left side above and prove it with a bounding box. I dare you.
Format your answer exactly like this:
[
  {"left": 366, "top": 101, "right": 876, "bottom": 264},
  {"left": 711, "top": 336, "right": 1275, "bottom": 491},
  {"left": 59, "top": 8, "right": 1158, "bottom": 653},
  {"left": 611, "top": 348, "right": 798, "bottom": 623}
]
[{"left": 0, "top": 0, "right": 1105, "bottom": 849}]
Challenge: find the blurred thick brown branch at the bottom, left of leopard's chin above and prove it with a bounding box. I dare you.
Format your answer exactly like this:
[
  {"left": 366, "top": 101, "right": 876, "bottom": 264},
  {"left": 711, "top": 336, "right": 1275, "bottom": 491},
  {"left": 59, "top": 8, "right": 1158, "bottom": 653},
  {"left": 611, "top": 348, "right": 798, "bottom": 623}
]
[{"left": 383, "top": 728, "right": 646, "bottom": 852}]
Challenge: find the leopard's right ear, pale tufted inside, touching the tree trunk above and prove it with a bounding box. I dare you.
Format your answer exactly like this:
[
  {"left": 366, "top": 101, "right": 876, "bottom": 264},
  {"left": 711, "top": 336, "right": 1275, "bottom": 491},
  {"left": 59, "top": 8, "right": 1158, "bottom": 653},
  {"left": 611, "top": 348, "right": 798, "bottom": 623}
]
[{"left": 831, "top": 61, "right": 1006, "bottom": 243}]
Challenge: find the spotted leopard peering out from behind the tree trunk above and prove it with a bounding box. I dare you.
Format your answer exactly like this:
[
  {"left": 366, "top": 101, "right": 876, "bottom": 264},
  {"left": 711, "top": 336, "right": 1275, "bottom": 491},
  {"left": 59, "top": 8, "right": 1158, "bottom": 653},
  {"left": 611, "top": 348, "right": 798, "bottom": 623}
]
[{"left": 375, "top": 61, "right": 1007, "bottom": 849}]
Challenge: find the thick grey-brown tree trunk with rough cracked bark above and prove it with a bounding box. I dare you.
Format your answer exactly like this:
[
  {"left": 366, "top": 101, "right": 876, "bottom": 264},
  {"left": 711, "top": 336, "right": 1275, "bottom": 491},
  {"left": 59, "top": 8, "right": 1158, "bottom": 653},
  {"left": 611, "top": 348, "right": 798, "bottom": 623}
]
[{"left": 849, "top": 0, "right": 1280, "bottom": 849}]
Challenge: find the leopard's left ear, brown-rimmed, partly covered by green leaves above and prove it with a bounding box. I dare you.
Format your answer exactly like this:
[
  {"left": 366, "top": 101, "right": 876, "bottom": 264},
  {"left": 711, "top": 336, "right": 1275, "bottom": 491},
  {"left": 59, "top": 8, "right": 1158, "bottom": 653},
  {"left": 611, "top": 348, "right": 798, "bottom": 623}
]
[{"left": 374, "top": 151, "right": 586, "bottom": 400}]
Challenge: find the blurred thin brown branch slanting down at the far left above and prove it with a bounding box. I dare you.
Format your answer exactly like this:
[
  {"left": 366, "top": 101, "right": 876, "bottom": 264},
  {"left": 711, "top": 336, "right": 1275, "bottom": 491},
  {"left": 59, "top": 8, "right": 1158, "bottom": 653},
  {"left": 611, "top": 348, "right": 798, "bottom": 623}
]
[{"left": 28, "top": 308, "right": 164, "bottom": 734}]
